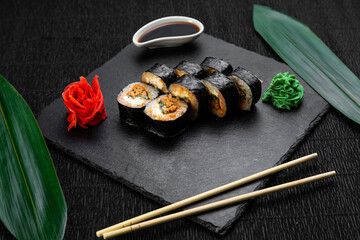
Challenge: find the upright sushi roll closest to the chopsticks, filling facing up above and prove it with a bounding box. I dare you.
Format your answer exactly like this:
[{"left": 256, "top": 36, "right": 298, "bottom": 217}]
[{"left": 144, "top": 94, "right": 188, "bottom": 137}]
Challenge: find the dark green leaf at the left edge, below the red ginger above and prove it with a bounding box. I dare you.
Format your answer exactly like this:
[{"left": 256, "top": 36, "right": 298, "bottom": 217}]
[{"left": 0, "top": 75, "right": 67, "bottom": 240}]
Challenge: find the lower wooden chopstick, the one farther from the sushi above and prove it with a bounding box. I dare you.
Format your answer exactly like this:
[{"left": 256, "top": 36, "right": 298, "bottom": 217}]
[{"left": 103, "top": 171, "right": 336, "bottom": 239}]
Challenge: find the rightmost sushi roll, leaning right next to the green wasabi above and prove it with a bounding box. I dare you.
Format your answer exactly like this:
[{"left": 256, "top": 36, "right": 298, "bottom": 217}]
[{"left": 229, "top": 67, "right": 261, "bottom": 111}]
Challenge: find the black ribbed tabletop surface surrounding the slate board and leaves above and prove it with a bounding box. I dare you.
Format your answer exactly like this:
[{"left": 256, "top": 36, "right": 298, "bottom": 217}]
[{"left": 0, "top": 0, "right": 360, "bottom": 239}]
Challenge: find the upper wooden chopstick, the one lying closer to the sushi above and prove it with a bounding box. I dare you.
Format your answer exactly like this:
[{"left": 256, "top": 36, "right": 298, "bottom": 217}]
[{"left": 96, "top": 153, "right": 318, "bottom": 237}]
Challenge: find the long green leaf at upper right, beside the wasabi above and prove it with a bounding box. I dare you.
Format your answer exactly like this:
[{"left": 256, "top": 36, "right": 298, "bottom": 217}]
[{"left": 253, "top": 5, "right": 360, "bottom": 124}]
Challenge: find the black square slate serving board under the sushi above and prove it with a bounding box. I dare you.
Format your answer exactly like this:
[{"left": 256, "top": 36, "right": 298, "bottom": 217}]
[{"left": 38, "top": 34, "right": 328, "bottom": 234}]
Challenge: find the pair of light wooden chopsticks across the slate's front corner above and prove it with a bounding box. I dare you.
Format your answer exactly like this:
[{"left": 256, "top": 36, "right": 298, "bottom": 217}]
[{"left": 96, "top": 153, "right": 336, "bottom": 239}]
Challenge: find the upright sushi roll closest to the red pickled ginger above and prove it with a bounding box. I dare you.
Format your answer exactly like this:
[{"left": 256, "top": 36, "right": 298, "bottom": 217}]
[{"left": 117, "top": 82, "right": 159, "bottom": 126}]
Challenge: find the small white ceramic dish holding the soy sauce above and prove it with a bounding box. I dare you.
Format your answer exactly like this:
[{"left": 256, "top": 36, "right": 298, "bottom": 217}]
[{"left": 133, "top": 16, "right": 204, "bottom": 48}]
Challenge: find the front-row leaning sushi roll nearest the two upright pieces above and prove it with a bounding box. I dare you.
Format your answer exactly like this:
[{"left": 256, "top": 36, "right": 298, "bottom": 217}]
[{"left": 169, "top": 75, "right": 209, "bottom": 120}]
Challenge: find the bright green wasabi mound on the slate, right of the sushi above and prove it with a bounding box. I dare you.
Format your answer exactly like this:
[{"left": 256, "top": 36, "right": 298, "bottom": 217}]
[{"left": 262, "top": 72, "right": 304, "bottom": 110}]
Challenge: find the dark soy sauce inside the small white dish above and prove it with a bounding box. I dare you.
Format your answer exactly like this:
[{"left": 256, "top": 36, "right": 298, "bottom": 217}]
[{"left": 138, "top": 22, "right": 200, "bottom": 43}]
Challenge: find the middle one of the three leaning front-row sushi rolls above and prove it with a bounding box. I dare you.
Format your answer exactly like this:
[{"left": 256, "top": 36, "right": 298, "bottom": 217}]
[{"left": 202, "top": 72, "right": 239, "bottom": 118}]
